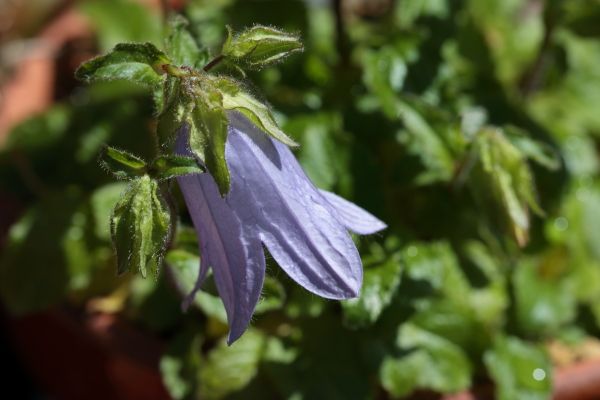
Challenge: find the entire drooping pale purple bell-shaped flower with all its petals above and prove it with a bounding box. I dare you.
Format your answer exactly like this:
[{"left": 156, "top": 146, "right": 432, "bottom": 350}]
[{"left": 176, "top": 112, "right": 385, "bottom": 343}]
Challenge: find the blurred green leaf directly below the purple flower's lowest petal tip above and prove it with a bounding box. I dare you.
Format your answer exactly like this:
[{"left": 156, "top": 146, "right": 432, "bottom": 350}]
[{"left": 199, "top": 329, "right": 265, "bottom": 400}]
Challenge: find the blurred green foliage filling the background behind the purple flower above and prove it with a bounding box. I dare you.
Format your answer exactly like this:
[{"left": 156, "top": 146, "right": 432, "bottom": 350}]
[{"left": 0, "top": 0, "right": 600, "bottom": 400}]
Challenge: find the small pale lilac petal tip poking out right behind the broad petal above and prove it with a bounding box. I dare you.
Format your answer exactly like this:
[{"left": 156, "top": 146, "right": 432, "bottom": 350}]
[{"left": 319, "top": 189, "right": 387, "bottom": 235}]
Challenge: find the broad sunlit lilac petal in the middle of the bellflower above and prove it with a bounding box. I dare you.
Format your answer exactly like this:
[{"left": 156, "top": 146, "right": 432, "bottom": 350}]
[{"left": 226, "top": 113, "right": 362, "bottom": 299}]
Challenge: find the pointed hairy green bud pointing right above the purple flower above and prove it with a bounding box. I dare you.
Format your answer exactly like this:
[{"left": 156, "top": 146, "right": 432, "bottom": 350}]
[{"left": 221, "top": 25, "right": 303, "bottom": 69}]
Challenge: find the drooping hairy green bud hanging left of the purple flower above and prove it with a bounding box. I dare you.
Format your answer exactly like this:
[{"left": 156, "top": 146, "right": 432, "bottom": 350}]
[{"left": 111, "top": 175, "right": 170, "bottom": 277}]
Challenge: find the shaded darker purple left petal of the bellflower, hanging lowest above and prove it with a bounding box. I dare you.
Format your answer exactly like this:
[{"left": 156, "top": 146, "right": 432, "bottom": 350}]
[{"left": 176, "top": 130, "right": 265, "bottom": 344}]
